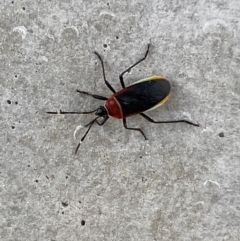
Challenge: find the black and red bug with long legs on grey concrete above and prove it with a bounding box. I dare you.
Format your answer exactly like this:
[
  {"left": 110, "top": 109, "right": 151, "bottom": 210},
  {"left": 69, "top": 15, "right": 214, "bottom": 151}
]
[{"left": 47, "top": 44, "right": 199, "bottom": 154}]
